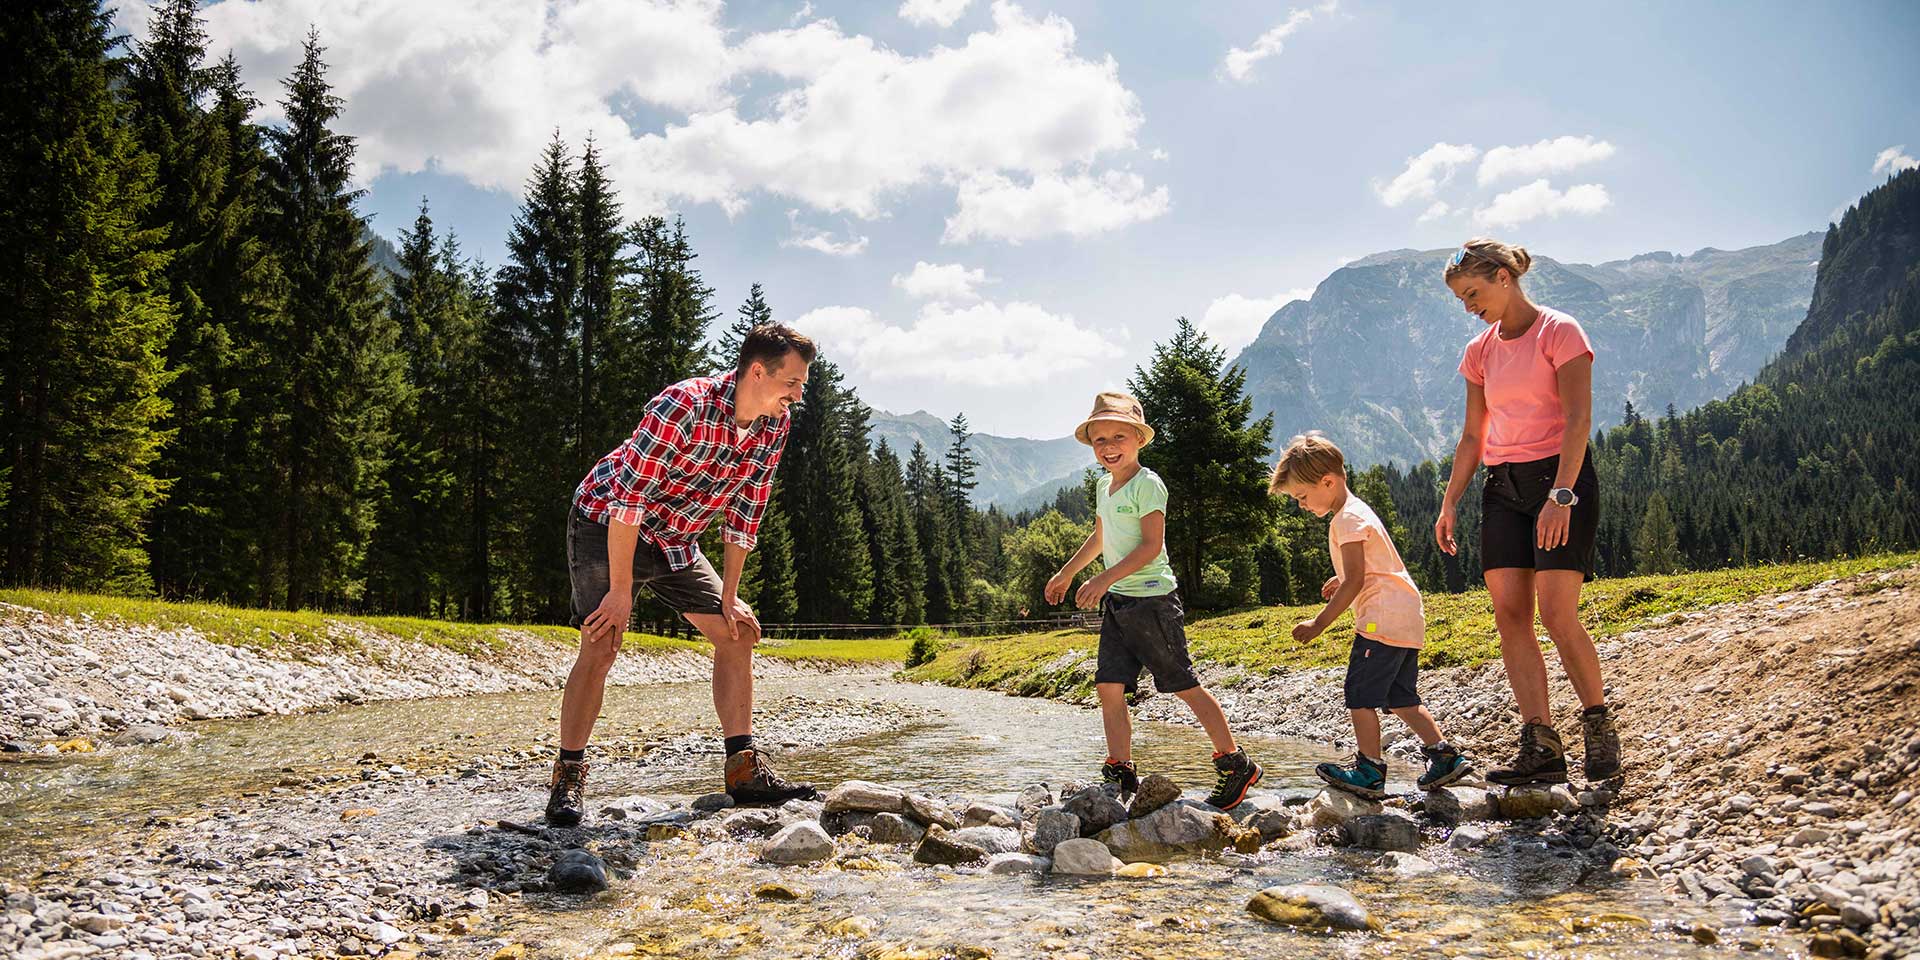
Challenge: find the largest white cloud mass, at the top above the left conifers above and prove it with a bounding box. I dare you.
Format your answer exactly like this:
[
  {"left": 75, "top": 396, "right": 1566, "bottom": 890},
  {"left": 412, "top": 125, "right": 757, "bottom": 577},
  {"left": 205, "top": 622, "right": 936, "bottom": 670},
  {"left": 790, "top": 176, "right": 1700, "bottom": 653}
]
[{"left": 117, "top": 0, "right": 1165, "bottom": 236}]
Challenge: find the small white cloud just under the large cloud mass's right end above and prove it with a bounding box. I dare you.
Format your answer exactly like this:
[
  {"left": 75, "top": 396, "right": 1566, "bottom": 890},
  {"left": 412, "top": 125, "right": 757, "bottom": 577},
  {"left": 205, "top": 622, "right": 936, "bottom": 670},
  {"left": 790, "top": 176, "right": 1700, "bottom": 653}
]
[{"left": 941, "top": 171, "right": 1173, "bottom": 244}]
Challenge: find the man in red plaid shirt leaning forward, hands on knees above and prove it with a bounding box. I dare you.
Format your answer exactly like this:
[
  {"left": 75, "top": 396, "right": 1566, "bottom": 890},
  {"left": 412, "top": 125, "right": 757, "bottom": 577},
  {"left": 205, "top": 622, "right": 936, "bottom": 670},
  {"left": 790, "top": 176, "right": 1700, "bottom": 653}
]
[{"left": 547, "top": 324, "right": 818, "bottom": 826}]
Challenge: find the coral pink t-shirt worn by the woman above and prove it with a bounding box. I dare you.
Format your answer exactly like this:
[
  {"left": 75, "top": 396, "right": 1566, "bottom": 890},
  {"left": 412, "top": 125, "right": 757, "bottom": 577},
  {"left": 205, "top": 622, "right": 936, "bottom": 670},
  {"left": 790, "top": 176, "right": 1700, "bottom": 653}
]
[{"left": 1459, "top": 307, "right": 1594, "bottom": 465}]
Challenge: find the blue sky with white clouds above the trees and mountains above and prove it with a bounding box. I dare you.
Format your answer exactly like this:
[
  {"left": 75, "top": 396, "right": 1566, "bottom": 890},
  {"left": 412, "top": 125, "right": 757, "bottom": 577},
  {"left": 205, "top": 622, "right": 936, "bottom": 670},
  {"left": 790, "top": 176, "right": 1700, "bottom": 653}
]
[{"left": 119, "top": 0, "right": 1920, "bottom": 436}]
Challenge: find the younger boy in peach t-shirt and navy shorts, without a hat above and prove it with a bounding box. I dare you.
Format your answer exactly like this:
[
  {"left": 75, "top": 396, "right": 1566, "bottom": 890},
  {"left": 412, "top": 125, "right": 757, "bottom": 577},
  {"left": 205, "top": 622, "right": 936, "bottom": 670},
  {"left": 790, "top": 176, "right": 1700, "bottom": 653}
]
[{"left": 1267, "top": 430, "right": 1473, "bottom": 801}]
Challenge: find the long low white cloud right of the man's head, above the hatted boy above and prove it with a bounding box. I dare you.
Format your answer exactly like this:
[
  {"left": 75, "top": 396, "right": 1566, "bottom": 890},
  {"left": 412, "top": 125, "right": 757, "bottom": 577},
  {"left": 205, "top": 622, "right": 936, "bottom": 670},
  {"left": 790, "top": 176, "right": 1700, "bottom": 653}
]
[{"left": 793, "top": 301, "right": 1123, "bottom": 388}]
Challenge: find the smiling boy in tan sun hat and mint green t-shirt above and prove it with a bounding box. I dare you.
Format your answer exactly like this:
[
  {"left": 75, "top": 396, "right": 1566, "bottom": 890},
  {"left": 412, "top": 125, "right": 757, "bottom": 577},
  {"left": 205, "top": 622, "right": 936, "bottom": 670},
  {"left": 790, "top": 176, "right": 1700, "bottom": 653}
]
[{"left": 1046, "top": 394, "right": 1261, "bottom": 810}]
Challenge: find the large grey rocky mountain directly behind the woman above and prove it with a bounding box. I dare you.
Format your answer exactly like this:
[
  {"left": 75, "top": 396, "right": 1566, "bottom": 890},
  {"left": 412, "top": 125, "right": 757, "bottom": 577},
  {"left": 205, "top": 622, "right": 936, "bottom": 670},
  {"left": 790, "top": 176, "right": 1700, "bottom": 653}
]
[{"left": 1235, "top": 232, "right": 1822, "bottom": 465}]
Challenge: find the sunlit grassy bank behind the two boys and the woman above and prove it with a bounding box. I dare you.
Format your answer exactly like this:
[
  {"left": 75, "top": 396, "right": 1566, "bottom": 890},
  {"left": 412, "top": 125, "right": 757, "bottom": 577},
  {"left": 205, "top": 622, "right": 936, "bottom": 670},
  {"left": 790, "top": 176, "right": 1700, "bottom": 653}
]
[{"left": 906, "top": 553, "right": 1920, "bottom": 697}]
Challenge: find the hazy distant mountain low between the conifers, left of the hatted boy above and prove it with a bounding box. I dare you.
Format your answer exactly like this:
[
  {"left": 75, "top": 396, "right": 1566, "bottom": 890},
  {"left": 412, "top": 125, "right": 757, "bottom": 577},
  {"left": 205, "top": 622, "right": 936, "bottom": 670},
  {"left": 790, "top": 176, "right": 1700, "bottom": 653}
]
[{"left": 872, "top": 411, "right": 1092, "bottom": 511}]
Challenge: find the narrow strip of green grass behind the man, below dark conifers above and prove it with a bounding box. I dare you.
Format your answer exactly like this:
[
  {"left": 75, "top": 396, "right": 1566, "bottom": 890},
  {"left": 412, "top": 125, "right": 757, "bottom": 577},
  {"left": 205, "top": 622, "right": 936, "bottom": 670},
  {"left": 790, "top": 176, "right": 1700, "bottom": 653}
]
[{"left": 0, "top": 589, "right": 908, "bottom": 662}]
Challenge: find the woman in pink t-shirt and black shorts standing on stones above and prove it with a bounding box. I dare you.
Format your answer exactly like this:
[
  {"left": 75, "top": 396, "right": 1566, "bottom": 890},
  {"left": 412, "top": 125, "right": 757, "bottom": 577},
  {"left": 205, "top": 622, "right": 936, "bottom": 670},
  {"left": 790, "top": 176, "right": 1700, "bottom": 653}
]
[{"left": 1434, "top": 238, "right": 1620, "bottom": 787}]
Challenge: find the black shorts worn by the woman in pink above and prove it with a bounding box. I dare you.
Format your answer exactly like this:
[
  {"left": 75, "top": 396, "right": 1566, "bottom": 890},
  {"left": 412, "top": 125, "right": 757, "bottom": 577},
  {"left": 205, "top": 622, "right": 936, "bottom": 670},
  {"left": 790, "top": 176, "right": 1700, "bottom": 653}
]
[{"left": 1480, "top": 447, "right": 1599, "bottom": 580}]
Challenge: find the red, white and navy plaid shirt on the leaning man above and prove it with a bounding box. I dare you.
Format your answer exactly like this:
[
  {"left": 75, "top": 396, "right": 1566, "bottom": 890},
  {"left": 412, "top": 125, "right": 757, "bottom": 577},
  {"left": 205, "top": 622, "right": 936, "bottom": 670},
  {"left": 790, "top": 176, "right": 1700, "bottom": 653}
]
[{"left": 574, "top": 372, "right": 793, "bottom": 570}]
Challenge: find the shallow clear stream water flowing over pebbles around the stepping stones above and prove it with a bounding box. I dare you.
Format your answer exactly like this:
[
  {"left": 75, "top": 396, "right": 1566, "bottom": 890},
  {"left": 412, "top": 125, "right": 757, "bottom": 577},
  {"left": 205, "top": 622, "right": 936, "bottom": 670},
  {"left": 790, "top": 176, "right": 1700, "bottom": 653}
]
[{"left": 0, "top": 676, "right": 1793, "bottom": 958}]
